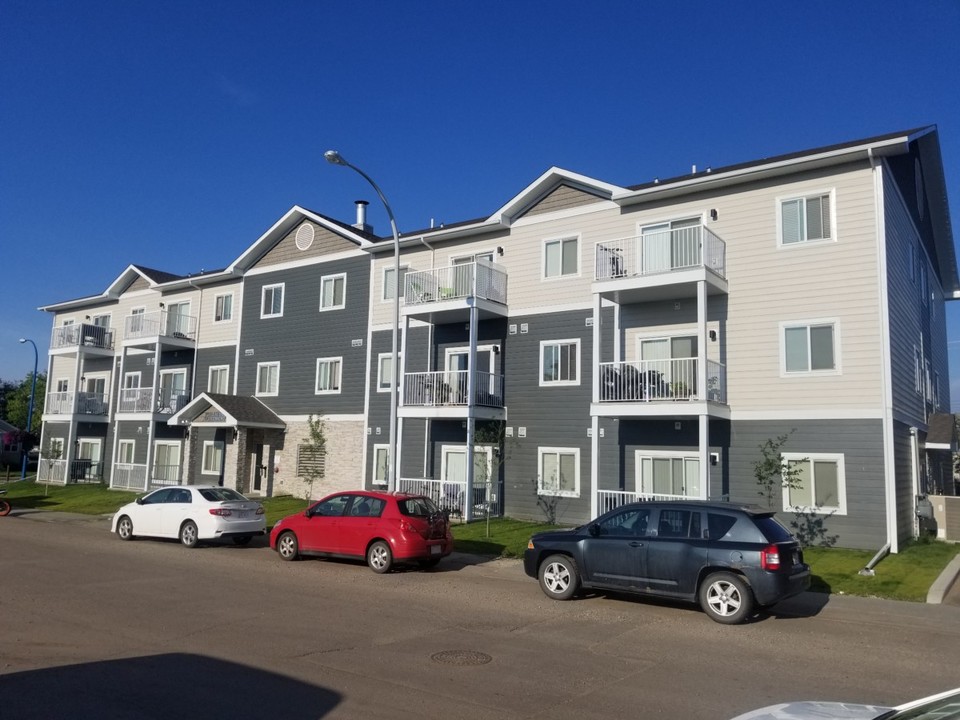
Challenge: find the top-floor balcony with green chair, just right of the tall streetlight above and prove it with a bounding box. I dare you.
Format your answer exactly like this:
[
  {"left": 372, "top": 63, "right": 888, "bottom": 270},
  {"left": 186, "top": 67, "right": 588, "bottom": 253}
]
[{"left": 403, "top": 260, "right": 507, "bottom": 324}]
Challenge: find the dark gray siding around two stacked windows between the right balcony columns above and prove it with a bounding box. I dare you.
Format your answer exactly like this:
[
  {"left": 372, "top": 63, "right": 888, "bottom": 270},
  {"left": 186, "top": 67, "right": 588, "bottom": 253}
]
[{"left": 503, "top": 311, "right": 593, "bottom": 524}]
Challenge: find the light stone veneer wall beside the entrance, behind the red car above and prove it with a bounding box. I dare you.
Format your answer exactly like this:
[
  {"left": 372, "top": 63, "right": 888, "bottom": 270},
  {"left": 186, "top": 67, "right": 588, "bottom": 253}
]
[{"left": 273, "top": 416, "right": 366, "bottom": 499}]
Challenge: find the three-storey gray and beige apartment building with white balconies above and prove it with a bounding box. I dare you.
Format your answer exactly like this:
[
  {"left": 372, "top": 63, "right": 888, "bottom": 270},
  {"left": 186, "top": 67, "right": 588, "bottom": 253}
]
[{"left": 33, "top": 128, "right": 960, "bottom": 552}]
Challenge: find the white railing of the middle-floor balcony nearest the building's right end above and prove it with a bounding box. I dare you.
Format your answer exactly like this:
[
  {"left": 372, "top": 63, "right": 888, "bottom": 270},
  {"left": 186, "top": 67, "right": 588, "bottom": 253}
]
[{"left": 600, "top": 358, "right": 726, "bottom": 402}]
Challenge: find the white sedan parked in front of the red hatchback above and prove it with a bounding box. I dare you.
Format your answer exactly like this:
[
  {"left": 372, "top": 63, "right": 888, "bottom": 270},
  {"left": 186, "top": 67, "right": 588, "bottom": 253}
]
[{"left": 110, "top": 485, "right": 267, "bottom": 547}]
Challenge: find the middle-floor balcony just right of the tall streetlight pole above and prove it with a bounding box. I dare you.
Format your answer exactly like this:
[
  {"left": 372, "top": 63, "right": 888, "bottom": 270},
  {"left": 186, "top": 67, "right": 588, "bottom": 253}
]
[{"left": 400, "top": 370, "right": 504, "bottom": 419}]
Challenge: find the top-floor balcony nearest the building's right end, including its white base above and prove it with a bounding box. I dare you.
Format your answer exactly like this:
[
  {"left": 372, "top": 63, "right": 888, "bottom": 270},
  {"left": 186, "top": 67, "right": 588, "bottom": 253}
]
[{"left": 593, "top": 225, "right": 727, "bottom": 302}]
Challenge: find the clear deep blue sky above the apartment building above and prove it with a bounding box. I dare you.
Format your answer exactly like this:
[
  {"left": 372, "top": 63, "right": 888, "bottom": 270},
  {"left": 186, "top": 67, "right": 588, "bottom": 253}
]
[{"left": 0, "top": 0, "right": 960, "bottom": 408}]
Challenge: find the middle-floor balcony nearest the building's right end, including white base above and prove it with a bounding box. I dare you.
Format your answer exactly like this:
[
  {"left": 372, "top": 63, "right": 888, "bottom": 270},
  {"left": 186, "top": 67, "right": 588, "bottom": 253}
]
[{"left": 597, "top": 358, "right": 727, "bottom": 415}]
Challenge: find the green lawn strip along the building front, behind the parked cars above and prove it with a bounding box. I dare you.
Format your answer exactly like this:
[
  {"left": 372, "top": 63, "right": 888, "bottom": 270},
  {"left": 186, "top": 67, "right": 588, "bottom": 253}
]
[{"left": 0, "top": 475, "right": 960, "bottom": 602}]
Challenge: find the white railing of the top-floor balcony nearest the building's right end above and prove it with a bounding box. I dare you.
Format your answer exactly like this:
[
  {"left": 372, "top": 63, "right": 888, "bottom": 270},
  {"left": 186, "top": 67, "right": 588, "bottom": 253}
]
[{"left": 594, "top": 225, "right": 726, "bottom": 280}]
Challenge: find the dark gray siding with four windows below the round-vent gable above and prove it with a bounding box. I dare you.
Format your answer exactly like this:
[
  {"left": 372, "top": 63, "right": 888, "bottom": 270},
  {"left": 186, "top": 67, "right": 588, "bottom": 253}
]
[{"left": 237, "top": 256, "right": 370, "bottom": 415}]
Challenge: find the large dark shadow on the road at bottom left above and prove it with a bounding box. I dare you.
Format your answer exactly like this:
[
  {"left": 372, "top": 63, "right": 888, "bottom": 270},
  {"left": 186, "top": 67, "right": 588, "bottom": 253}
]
[{"left": 0, "top": 653, "right": 341, "bottom": 720}]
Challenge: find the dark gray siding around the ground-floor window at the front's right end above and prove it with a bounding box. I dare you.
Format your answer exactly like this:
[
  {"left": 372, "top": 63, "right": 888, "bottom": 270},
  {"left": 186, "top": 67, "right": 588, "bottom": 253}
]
[{"left": 728, "top": 420, "right": 884, "bottom": 550}]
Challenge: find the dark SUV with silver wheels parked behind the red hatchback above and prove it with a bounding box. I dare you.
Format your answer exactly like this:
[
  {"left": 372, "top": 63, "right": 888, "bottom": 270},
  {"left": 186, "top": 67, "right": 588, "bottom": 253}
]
[{"left": 523, "top": 501, "right": 810, "bottom": 624}]
